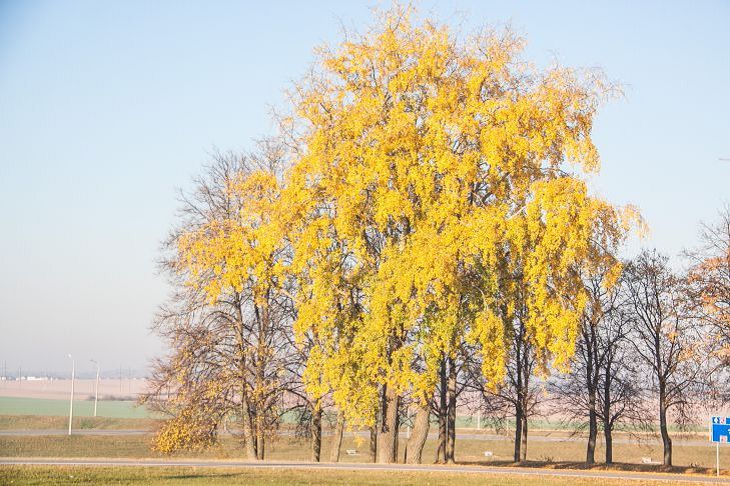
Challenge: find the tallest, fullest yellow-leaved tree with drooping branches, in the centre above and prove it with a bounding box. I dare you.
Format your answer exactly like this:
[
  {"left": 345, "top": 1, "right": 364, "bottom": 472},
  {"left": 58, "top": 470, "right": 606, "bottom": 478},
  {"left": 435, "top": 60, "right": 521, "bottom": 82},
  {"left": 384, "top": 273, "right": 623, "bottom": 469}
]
[{"left": 282, "top": 7, "right": 628, "bottom": 462}]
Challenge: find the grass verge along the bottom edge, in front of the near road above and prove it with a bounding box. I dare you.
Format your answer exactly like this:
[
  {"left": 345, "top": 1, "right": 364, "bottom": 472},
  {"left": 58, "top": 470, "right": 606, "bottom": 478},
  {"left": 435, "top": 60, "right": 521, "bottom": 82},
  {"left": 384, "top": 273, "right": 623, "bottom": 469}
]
[{"left": 0, "top": 466, "right": 684, "bottom": 486}]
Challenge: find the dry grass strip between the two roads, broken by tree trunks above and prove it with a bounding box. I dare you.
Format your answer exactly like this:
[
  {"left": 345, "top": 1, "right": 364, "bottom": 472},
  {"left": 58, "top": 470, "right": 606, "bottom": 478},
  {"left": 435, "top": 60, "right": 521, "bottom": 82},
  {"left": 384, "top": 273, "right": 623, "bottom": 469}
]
[{"left": 0, "top": 435, "right": 730, "bottom": 474}]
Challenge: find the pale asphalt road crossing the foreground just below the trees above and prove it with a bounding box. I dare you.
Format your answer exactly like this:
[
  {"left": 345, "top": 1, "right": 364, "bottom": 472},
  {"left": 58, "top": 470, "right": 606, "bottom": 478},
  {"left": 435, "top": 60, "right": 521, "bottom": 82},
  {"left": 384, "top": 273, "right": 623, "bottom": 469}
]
[{"left": 0, "top": 458, "right": 730, "bottom": 484}]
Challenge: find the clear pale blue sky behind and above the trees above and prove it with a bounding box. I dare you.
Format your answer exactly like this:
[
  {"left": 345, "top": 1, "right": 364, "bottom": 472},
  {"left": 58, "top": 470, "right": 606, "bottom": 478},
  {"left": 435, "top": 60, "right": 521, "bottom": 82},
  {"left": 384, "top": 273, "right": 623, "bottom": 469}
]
[{"left": 0, "top": 0, "right": 730, "bottom": 372}]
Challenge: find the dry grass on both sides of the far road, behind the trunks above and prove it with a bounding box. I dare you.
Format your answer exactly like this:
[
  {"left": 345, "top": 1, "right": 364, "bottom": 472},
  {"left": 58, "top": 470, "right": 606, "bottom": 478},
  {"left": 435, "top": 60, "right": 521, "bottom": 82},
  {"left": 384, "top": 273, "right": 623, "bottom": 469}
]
[{"left": 0, "top": 415, "right": 716, "bottom": 474}]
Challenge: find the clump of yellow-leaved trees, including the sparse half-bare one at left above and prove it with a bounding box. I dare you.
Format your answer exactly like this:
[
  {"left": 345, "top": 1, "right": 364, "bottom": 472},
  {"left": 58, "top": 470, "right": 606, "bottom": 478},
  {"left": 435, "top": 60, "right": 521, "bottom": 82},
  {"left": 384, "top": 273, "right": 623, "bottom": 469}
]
[{"left": 148, "top": 6, "right": 633, "bottom": 463}]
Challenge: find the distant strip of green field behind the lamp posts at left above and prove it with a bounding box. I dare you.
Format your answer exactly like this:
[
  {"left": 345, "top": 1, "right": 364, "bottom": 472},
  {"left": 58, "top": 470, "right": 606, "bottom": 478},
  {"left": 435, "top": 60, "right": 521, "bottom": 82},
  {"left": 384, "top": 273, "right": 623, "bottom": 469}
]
[{"left": 0, "top": 397, "right": 153, "bottom": 418}]
